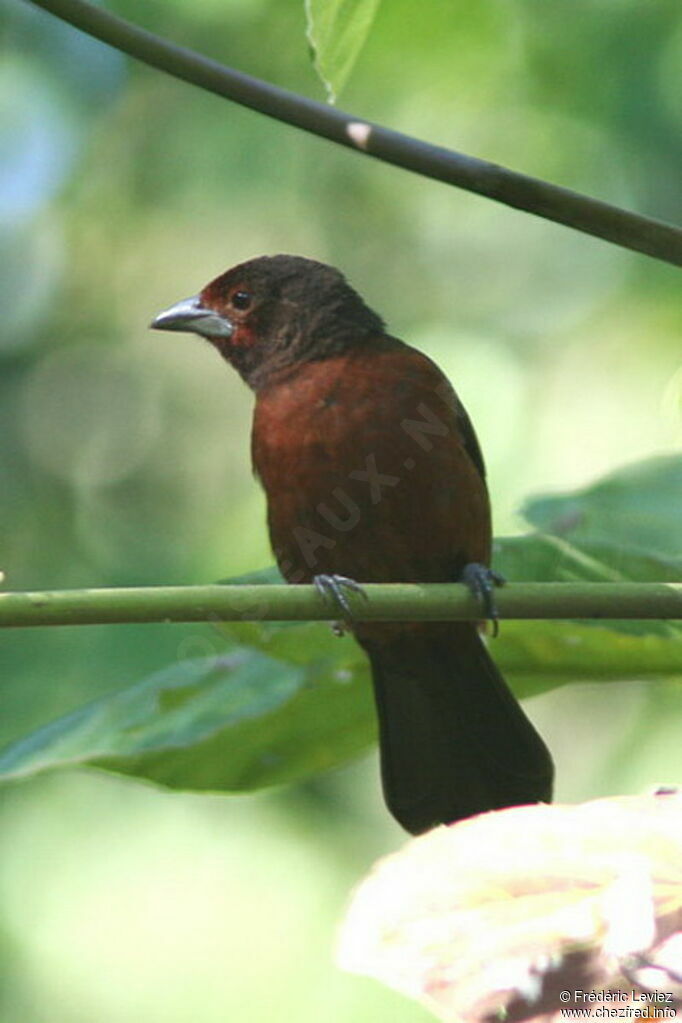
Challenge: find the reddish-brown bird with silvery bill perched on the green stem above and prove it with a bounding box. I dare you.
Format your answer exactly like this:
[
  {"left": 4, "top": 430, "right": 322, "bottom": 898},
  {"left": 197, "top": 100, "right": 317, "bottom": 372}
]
[{"left": 151, "top": 255, "right": 553, "bottom": 834}]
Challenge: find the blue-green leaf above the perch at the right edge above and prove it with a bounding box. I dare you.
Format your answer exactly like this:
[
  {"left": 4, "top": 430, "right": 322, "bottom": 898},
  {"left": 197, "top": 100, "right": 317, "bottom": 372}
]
[{"left": 522, "top": 454, "right": 682, "bottom": 556}]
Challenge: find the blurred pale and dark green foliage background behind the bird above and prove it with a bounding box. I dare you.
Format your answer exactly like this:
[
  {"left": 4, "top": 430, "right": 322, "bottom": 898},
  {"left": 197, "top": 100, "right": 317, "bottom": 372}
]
[{"left": 0, "top": 0, "right": 682, "bottom": 1023}]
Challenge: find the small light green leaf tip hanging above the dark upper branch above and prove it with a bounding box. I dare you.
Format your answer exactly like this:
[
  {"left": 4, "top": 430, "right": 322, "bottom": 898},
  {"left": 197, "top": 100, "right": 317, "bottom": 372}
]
[{"left": 306, "top": 0, "right": 379, "bottom": 103}]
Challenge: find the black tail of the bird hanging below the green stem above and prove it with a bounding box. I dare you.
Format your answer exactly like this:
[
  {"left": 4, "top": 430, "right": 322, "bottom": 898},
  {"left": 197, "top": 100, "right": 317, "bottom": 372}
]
[{"left": 361, "top": 623, "right": 553, "bottom": 834}]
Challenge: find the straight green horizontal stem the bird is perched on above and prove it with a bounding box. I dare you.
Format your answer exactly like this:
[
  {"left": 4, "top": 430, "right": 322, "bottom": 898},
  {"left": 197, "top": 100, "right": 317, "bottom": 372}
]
[{"left": 0, "top": 583, "right": 682, "bottom": 628}]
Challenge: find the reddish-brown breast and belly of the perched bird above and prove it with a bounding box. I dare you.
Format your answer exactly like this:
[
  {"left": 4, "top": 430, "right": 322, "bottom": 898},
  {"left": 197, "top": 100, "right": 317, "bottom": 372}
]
[{"left": 252, "top": 339, "right": 491, "bottom": 582}]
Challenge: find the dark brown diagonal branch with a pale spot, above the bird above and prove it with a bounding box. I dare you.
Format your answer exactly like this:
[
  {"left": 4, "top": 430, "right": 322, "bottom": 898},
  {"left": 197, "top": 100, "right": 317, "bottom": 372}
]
[{"left": 24, "top": 0, "right": 682, "bottom": 266}]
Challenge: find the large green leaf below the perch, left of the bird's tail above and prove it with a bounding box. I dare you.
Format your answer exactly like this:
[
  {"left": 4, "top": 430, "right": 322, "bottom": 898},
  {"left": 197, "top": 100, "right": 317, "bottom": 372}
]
[{"left": 0, "top": 648, "right": 375, "bottom": 792}]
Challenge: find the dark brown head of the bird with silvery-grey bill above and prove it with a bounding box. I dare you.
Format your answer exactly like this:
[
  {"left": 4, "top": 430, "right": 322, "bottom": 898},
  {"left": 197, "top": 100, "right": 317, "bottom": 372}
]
[{"left": 151, "top": 256, "right": 383, "bottom": 390}]
